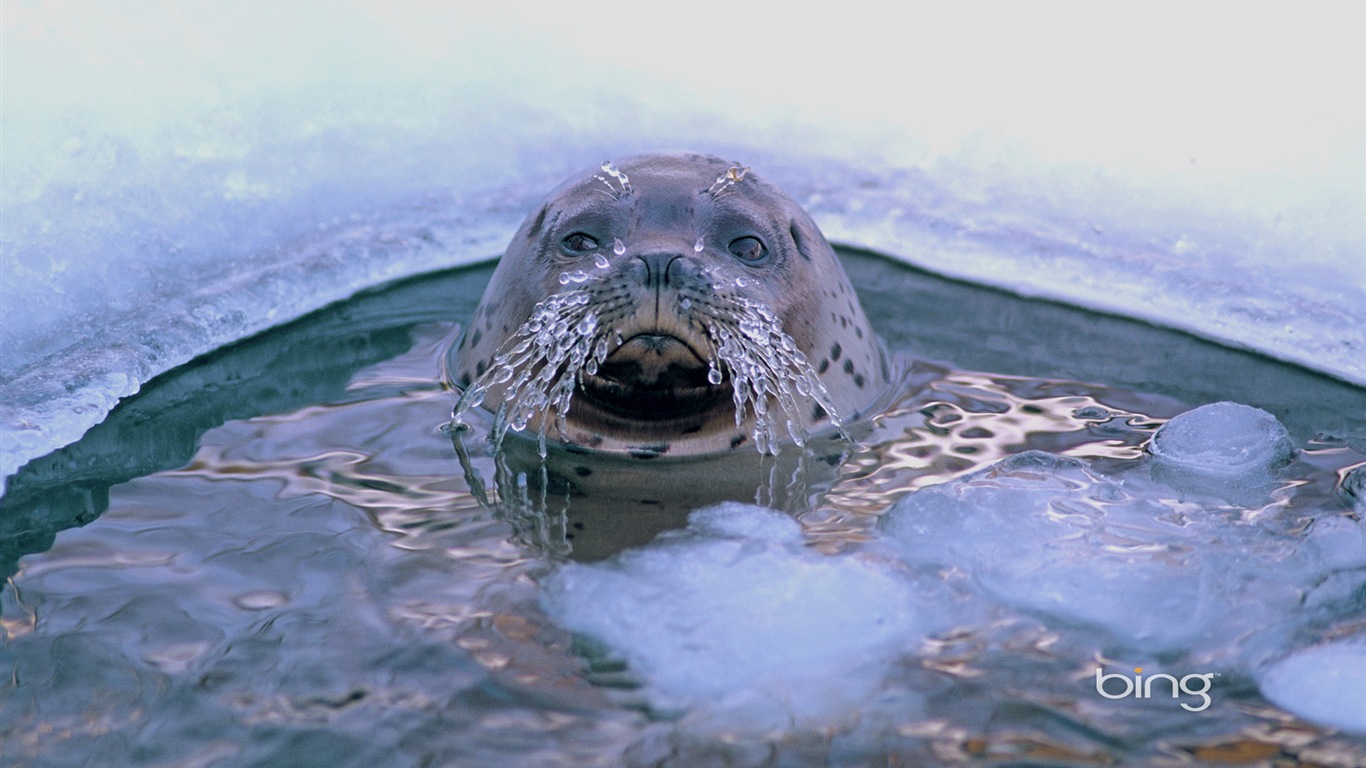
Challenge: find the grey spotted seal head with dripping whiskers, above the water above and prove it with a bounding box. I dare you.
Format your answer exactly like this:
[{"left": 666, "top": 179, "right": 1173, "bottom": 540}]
[{"left": 447, "top": 154, "right": 888, "bottom": 458}]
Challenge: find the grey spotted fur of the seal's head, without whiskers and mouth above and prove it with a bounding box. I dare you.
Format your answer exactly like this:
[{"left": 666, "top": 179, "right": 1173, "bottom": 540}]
[{"left": 447, "top": 154, "right": 888, "bottom": 459}]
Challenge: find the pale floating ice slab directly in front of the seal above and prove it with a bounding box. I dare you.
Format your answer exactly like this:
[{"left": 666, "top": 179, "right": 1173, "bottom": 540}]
[{"left": 544, "top": 503, "right": 930, "bottom": 722}]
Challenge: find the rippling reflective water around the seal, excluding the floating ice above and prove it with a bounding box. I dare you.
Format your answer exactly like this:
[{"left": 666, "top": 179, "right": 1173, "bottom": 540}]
[{"left": 0, "top": 248, "right": 1366, "bottom": 765}]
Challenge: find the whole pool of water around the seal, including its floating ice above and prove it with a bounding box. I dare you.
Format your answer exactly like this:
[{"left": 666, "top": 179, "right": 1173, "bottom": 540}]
[{"left": 0, "top": 251, "right": 1366, "bottom": 765}]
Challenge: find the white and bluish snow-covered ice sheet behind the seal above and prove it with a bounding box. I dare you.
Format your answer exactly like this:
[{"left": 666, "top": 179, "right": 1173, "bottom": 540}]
[{"left": 0, "top": 0, "right": 1366, "bottom": 489}]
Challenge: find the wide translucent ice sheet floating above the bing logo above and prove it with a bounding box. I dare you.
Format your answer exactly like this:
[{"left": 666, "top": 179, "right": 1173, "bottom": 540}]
[{"left": 881, "top": 451, "right": 1305, "bottom": 655}]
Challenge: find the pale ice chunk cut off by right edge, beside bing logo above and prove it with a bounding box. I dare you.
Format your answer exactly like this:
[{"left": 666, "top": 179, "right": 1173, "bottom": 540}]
[{"left": 1259, "top": 640, "right": 1366, "bottom": 734}]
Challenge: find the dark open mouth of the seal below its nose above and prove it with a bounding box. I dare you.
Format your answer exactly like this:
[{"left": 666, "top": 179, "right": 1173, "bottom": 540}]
[{"left": 581, "top": 332, "right": 731, "bottom": 421}]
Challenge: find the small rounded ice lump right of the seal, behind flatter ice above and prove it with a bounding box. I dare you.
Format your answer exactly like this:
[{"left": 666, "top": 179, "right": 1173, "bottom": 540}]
[{"left": 1149, "top": 402, "right": 1295, "bottom": 477}]
